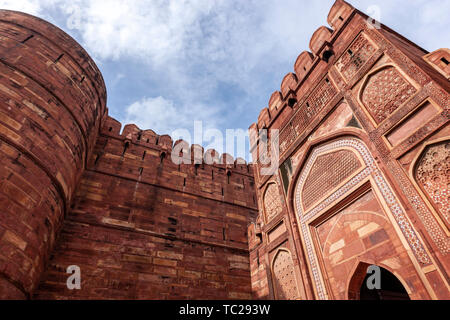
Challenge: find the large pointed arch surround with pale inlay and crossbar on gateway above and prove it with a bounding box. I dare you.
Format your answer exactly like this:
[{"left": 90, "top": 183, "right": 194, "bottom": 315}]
[{"left": 290, "top": 134, "right": 431, "bottom": 299}]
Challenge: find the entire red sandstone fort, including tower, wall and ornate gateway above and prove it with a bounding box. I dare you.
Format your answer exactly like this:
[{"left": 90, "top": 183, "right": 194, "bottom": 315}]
[{"left": 0, "top": 0, "right": 450, "bottom": 300}]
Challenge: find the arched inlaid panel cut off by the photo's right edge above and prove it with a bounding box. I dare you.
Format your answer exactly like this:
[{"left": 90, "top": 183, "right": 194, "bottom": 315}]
[{"left": 415, "top": 140, "right": 450, "bottom": 223}]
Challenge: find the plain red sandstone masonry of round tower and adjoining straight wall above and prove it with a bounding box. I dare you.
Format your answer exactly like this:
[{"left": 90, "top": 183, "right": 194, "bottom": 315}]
[{"left": 0, "top": 10, "right": 257, "bottom": 299}]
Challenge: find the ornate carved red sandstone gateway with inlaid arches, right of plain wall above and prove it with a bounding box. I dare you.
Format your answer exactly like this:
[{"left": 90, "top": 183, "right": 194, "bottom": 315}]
[{"left": 249, "top": 0, "right": 450, "bottom": 299}]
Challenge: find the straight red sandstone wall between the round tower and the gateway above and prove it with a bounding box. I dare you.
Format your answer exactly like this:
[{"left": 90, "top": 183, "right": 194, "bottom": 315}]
[{"left": 35, "top": 118, "right": 257, "bottom": 299}]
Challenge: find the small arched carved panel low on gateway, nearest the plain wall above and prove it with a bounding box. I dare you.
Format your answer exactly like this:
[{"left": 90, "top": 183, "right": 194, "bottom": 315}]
[{"left": 273, "top": 250, "right": 298, "bottom": 300}]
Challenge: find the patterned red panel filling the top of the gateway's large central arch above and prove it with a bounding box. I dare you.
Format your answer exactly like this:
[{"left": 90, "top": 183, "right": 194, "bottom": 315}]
[{"left": 302, "top": 150, "right": 362, "bottom": 209}]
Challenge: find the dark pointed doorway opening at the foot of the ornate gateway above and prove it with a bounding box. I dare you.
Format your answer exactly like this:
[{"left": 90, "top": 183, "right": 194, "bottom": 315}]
[{"left": 349, "top": 263, "right": 411, "bottom": 300}]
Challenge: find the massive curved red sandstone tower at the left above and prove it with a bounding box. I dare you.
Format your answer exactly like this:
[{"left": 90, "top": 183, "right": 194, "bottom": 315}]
[{"left": 0, "top": 10, "right": 106, "bottom": 299}]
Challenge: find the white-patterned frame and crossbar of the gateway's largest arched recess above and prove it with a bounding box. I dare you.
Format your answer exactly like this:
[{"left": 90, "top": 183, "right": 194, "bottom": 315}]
[{"left": 291, "top": 135, "right": 432, "bottom": 299}]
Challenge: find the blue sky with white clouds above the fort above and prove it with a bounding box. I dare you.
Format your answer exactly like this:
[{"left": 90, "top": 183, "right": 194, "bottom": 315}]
[{"left": 0, "top": 0, "right": 450, "bottom": 158}]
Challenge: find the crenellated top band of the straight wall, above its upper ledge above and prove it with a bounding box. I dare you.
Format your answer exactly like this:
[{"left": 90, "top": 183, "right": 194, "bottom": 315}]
[{"left": 88, "top": 116, "right": 256, "bottom": 208}]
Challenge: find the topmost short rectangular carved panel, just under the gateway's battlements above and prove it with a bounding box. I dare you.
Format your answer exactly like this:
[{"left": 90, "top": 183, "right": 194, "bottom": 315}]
[{"left": 336, "top": 34, "right": 377, "bottom": 82}]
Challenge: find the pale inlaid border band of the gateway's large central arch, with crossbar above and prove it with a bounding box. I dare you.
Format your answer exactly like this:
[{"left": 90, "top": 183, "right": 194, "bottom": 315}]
[{"left": 294, "top": 137, "right": 431, "bottom": 300}]
